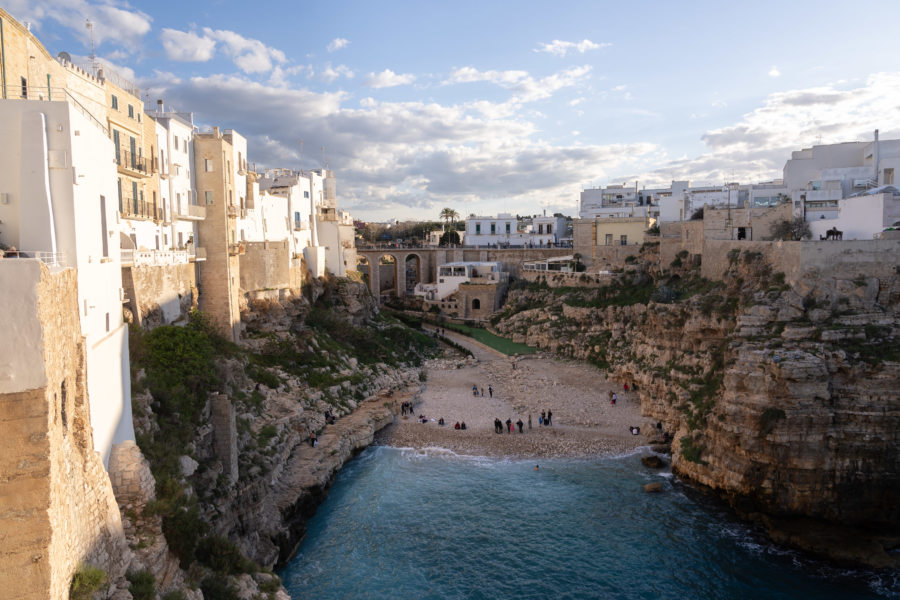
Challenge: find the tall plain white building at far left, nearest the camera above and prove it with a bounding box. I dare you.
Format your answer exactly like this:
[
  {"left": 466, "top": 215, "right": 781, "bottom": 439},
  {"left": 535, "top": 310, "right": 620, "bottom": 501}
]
[{"left": 0, "top": 100, "right": 134, "bottom": 463}]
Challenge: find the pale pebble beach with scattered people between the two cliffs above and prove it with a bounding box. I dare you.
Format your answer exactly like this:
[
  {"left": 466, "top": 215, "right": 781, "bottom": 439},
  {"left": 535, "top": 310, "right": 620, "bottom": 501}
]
[{"left": 376, "top": 332, "right": 653, "bottom": 458}]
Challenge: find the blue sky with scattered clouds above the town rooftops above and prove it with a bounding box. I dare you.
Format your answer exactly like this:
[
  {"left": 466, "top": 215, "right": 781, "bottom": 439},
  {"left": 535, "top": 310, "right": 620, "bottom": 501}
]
[{"left": 7, "top": 0, "right": 900, "bottom": 221}]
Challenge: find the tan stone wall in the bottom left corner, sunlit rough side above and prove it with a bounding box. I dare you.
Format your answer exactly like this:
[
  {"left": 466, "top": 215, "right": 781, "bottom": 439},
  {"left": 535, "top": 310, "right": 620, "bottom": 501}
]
[{"left": 0, "top": 260, "right": 130, "bottom": 600}]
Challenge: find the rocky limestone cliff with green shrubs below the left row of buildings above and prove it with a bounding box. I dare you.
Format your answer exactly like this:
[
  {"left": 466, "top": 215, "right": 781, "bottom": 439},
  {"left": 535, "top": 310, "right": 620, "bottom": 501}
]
[{"left": 126, "top": 280, "right": 434, "bottom": 598}]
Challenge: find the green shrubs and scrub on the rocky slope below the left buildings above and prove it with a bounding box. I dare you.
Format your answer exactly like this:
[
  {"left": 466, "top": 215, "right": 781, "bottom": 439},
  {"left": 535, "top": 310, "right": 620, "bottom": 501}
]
[{"left": 129, "top": 280, "right": 435, "bottom": 597}]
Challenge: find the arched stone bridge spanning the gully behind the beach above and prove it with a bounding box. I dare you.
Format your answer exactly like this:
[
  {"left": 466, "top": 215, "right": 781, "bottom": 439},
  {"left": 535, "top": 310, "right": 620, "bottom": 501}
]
[{"left": 356, "top": 246, "right": 574, "bottom": 300}]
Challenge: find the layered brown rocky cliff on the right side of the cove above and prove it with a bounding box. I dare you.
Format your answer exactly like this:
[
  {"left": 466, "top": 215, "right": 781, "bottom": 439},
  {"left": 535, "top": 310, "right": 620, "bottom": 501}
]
[{"left": 495, "top": 248, "right": 900, "bottom": 566}]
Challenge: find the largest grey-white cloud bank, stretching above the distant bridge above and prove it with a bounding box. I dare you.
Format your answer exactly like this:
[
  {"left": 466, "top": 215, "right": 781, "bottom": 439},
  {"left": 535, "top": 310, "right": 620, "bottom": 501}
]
[{"left": 148, "top": 75, "right": 655, "bottom": 218}]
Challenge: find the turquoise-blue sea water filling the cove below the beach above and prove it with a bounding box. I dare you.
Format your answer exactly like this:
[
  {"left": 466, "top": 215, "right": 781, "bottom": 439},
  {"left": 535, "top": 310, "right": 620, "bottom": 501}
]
[{"left": 281, "top": 447, "right": 900, "bottom": 600}]
